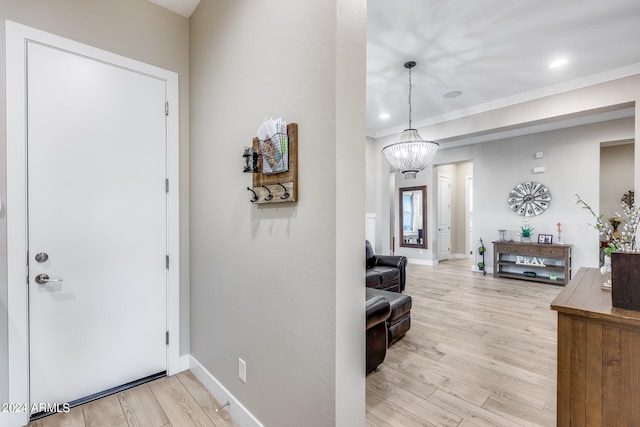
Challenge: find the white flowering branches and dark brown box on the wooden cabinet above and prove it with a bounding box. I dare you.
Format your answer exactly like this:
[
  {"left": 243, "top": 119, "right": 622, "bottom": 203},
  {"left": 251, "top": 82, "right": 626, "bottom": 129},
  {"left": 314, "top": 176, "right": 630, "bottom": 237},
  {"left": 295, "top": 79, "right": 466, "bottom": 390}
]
[{"left": 576, "top": 193, "right": 640, "bottom": 310}]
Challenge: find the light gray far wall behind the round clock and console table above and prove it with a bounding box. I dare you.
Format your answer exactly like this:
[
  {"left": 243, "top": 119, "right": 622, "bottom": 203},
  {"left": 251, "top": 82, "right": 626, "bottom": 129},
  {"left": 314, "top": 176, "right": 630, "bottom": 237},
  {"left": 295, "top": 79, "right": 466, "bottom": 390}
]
[{"left": 372, "top": 118, "right": 634, "bottom": 273}]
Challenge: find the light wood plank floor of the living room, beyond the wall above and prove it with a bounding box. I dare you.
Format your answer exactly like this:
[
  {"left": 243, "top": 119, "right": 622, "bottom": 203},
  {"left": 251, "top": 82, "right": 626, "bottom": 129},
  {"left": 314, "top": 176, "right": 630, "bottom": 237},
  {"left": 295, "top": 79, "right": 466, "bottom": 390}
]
[{"left": 366, "top": 260, "right": 562, "bottom": 427}]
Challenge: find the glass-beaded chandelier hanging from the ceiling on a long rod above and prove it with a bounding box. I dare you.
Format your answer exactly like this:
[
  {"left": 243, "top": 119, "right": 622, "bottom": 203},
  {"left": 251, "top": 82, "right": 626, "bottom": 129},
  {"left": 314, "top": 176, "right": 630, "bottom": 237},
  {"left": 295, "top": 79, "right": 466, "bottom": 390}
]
[{"left": 382, "top": 61, "right": 439, "bottom": 179}]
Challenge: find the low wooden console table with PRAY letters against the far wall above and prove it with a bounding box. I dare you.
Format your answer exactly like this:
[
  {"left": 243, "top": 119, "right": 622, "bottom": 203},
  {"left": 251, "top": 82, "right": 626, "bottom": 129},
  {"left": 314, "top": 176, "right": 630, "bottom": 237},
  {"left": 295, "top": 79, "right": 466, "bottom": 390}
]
[{"left": 493, "top": 241, "right": 572, "bottom": 285}]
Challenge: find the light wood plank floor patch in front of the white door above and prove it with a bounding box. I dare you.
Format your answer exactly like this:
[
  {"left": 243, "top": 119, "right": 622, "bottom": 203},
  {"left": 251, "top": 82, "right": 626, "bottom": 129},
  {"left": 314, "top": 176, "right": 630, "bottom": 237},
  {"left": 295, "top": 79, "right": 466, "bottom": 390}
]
[{"left": 28, "top": 371, "right": 238, "bottom": 427}]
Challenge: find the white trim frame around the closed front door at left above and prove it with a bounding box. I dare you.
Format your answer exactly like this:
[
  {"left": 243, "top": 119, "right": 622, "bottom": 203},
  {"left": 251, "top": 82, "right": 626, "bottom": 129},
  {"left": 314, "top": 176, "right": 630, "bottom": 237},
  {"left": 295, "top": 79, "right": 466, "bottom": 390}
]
[{"left": 6, "top": 21, "right": 181, "bottom": 425}]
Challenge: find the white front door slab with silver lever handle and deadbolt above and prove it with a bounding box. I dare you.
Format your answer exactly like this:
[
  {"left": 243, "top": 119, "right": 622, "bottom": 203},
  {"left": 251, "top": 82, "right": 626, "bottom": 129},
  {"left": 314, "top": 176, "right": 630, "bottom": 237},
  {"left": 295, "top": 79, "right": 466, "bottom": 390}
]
[{"left": 27, "top": 42, "right": 167, "bottom": 412}]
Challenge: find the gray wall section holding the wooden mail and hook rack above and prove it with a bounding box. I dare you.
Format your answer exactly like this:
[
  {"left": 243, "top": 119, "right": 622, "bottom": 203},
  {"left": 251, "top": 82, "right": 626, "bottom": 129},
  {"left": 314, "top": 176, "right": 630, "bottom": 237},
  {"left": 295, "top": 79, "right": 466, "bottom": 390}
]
[{"left": 190, "top": 0, "right": 366, "bottom": 426}]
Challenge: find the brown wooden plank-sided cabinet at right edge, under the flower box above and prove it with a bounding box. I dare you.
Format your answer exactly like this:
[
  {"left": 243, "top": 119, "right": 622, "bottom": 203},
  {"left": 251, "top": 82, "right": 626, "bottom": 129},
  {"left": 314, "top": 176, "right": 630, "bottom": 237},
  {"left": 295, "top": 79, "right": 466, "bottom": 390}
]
[{"left": 551, "top": 268, "right": 640, "bottom": 427}]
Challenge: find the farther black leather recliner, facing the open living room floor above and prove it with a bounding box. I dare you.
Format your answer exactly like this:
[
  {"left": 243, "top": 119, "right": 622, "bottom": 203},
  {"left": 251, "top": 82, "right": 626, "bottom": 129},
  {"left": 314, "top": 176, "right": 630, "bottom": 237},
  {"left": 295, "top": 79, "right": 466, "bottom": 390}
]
[{"left": 366, "top": 240, "right": 407, "bottom": 292}]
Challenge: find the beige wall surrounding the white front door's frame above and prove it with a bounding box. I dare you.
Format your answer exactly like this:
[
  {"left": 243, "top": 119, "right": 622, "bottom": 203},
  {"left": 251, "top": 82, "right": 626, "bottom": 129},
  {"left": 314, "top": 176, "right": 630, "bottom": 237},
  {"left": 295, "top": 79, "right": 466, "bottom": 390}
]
[{"left": 0, "top": 0, "right": 189, "bottom": 412}]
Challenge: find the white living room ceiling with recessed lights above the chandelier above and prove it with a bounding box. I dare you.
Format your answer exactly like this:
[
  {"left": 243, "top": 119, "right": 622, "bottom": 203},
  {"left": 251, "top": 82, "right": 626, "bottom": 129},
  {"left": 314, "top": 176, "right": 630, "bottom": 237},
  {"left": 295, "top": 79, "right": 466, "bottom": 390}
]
[{"left": 366, "top": 0, "right": 640, "bottom": 138}]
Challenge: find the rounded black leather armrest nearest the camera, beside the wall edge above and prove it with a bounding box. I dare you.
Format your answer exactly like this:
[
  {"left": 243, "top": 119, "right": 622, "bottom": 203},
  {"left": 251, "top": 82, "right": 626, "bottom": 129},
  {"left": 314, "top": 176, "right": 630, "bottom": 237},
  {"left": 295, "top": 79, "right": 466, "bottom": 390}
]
[{"left": 365, "top": 295, "right": 391, "bottom": 373}]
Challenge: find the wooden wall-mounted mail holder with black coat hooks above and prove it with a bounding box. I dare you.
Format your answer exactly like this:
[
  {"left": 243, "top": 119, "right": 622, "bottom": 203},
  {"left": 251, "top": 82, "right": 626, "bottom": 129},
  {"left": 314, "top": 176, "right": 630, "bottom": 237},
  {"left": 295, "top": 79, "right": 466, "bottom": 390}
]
[{"left": 251, "top": 123, "right": 298, "bottom": 204}]
